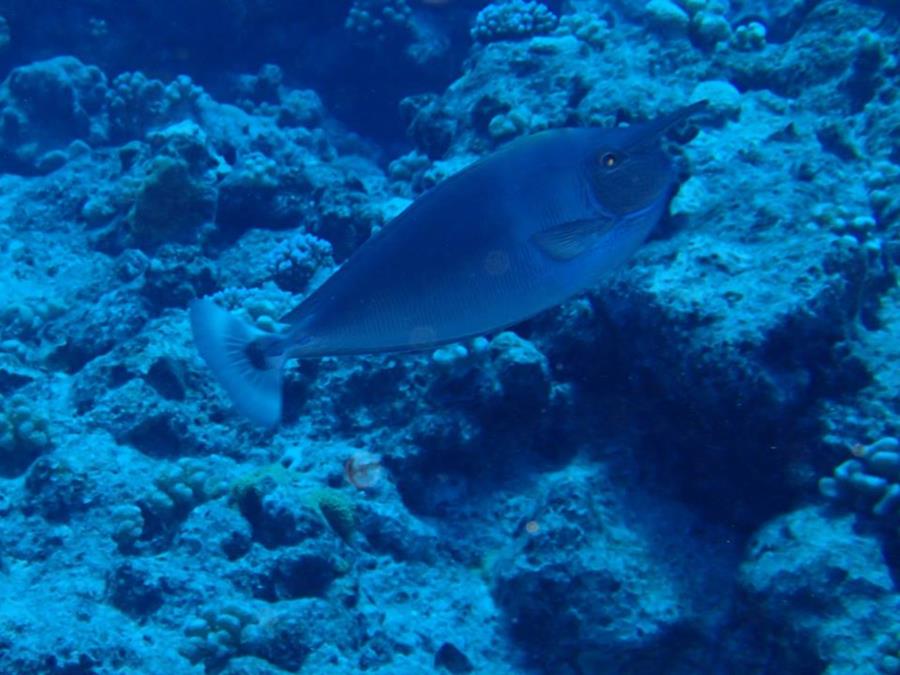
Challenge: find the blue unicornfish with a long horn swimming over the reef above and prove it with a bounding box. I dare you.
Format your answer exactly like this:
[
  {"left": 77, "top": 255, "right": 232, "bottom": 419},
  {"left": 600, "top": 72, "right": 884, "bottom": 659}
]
[{"left": 188, "top": 101, "right": 707, "bottom": 427}]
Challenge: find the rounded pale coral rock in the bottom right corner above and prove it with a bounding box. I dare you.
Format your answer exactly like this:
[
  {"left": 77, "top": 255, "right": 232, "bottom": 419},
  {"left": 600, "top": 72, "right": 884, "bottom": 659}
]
[{"left": 739, "top": 509, "right": 900, "bottom": 673}]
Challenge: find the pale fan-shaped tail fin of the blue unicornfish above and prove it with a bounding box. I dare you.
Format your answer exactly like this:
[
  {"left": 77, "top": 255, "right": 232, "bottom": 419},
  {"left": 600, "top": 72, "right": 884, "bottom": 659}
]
[{"left": 190, "top": 299, "right": 284, "bottom": 427}]
